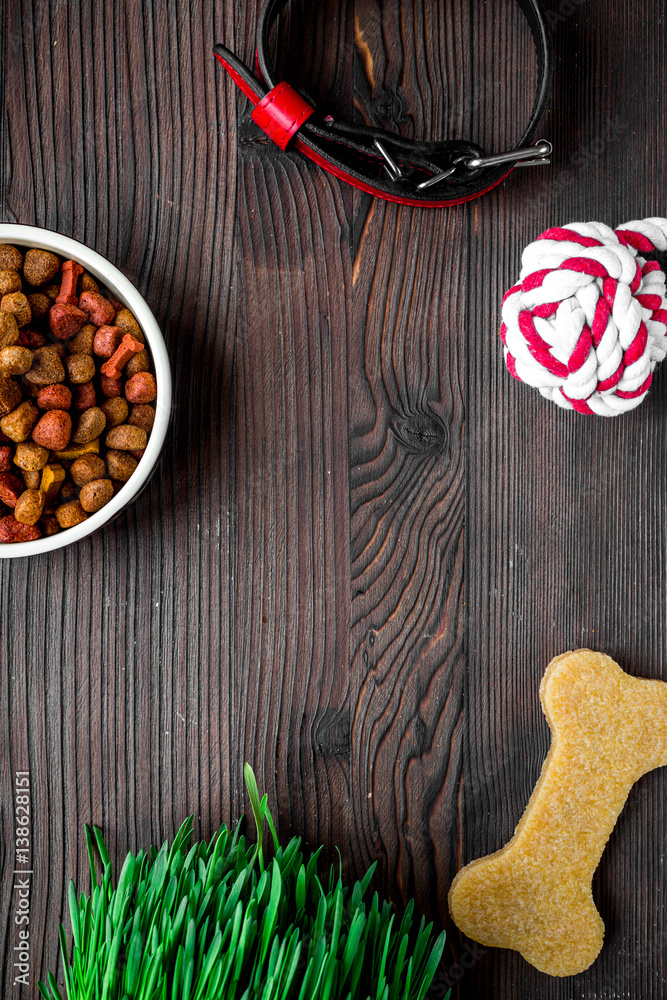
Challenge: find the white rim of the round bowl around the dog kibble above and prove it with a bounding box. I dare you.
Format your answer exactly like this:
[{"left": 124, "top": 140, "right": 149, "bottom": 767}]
[{"left": 0, "top": 223, "right": 171, "bottom": 559}]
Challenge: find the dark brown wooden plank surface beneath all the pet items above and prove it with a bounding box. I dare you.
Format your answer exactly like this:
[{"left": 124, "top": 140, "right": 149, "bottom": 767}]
[{"left": 0, "top": 0, "right": 667, "bottom": 1000}]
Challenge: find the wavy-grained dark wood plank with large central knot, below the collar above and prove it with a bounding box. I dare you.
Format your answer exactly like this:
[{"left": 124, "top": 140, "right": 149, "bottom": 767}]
[{"left": 350, "top": 191, "right": 465, "bottom": 916}]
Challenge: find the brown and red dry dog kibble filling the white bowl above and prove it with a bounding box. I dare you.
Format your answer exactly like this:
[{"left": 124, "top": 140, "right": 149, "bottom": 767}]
[{"left": 0, "top": 244, "right": 157, "bottom": 543}]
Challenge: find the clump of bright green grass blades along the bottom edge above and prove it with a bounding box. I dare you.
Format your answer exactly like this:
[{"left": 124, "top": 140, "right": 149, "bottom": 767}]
[{"left": 39, "top": 765, "right": 449, "bottom": 1000}]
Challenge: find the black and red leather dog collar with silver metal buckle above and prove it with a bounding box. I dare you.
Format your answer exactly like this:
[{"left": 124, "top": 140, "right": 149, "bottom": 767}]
[{"left": 213, "top": 0, "right": 553, "bottom": 207}]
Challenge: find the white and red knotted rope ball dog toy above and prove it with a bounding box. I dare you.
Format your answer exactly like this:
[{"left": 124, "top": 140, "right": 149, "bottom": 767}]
[{"left": 500, "top": 219, "right": 667, "bottom": 417}]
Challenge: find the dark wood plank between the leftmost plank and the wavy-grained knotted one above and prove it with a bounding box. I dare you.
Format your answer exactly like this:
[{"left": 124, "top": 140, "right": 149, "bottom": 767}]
[{"left": 233, "top": 0, "right": 352, "bottom": 850}]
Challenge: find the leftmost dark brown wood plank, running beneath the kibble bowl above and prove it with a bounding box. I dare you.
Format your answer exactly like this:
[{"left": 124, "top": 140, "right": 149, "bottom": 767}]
[{"left": 0, "top": 2, "right": 240, "bottom": 997}]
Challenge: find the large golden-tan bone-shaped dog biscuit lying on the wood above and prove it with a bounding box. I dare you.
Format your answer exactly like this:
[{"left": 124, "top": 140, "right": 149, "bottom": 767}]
[{"left": 449, "top": 649, "right": 667, "bottom": 976}]
